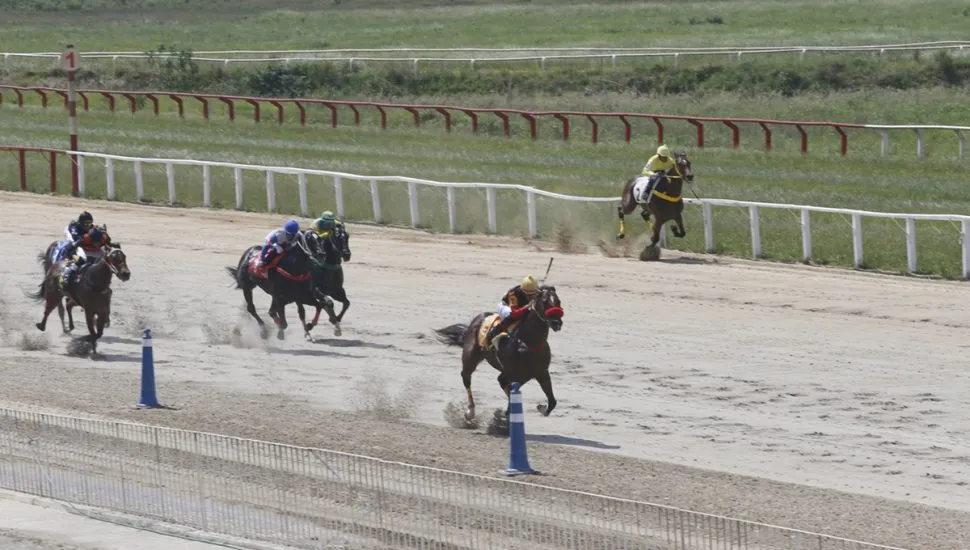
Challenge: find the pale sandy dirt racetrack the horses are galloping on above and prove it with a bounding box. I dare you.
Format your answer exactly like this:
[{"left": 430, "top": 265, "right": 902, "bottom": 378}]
[{"left": 0, "top": 193, "right": 970, "bottom": 550}]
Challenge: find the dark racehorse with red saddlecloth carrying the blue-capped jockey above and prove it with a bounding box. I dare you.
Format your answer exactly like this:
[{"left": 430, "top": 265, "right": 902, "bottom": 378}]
[{"left": 226, "top": 238, "right": 336, "bottom": 340}]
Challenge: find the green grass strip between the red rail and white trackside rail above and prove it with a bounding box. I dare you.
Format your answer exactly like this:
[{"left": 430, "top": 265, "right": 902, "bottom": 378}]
[{"left": 0, "top": 102, "right": 970, "bottom": 277}]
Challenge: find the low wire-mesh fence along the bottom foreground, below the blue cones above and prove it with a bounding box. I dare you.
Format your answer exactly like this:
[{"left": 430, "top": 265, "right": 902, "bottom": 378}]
[{"left": 0, "top": 408, "right": 900, "bottom": 550}]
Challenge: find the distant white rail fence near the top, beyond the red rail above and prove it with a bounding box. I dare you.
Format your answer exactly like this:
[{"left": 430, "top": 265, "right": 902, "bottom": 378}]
[{"left": 0, "top": 40, "right": 970, "bottom": 69}]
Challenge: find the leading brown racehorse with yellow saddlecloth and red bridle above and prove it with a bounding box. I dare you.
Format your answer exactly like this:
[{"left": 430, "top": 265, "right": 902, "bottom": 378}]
[{"left": 435, "top": 285, "right": 563, "bottom": 421}]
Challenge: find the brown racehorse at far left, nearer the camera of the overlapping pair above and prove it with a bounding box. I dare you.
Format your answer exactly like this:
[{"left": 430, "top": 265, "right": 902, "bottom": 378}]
[{"left": 31, "top": 245, "right": 131, "bottom": 353}]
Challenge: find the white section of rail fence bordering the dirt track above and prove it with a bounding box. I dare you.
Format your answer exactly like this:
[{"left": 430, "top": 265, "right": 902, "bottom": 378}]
[{"left": 51, "top": 152, "right": 970, "bottom": 278}]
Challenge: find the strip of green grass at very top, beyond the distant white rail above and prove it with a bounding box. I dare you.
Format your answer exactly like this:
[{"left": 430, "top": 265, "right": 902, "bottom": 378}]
[{"left": 0, "top": 0, "right": 970, "bottom": 52}]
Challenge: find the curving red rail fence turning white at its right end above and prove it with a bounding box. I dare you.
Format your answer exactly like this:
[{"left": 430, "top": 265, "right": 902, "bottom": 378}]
[{"left": 0, "top": 85, "right": 970, "bottom": 159}]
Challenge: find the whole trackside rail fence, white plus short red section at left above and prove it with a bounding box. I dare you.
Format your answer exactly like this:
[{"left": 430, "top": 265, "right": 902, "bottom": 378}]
[{"left": 0, "top": 147, "right": 970, "bottom": 278}]
